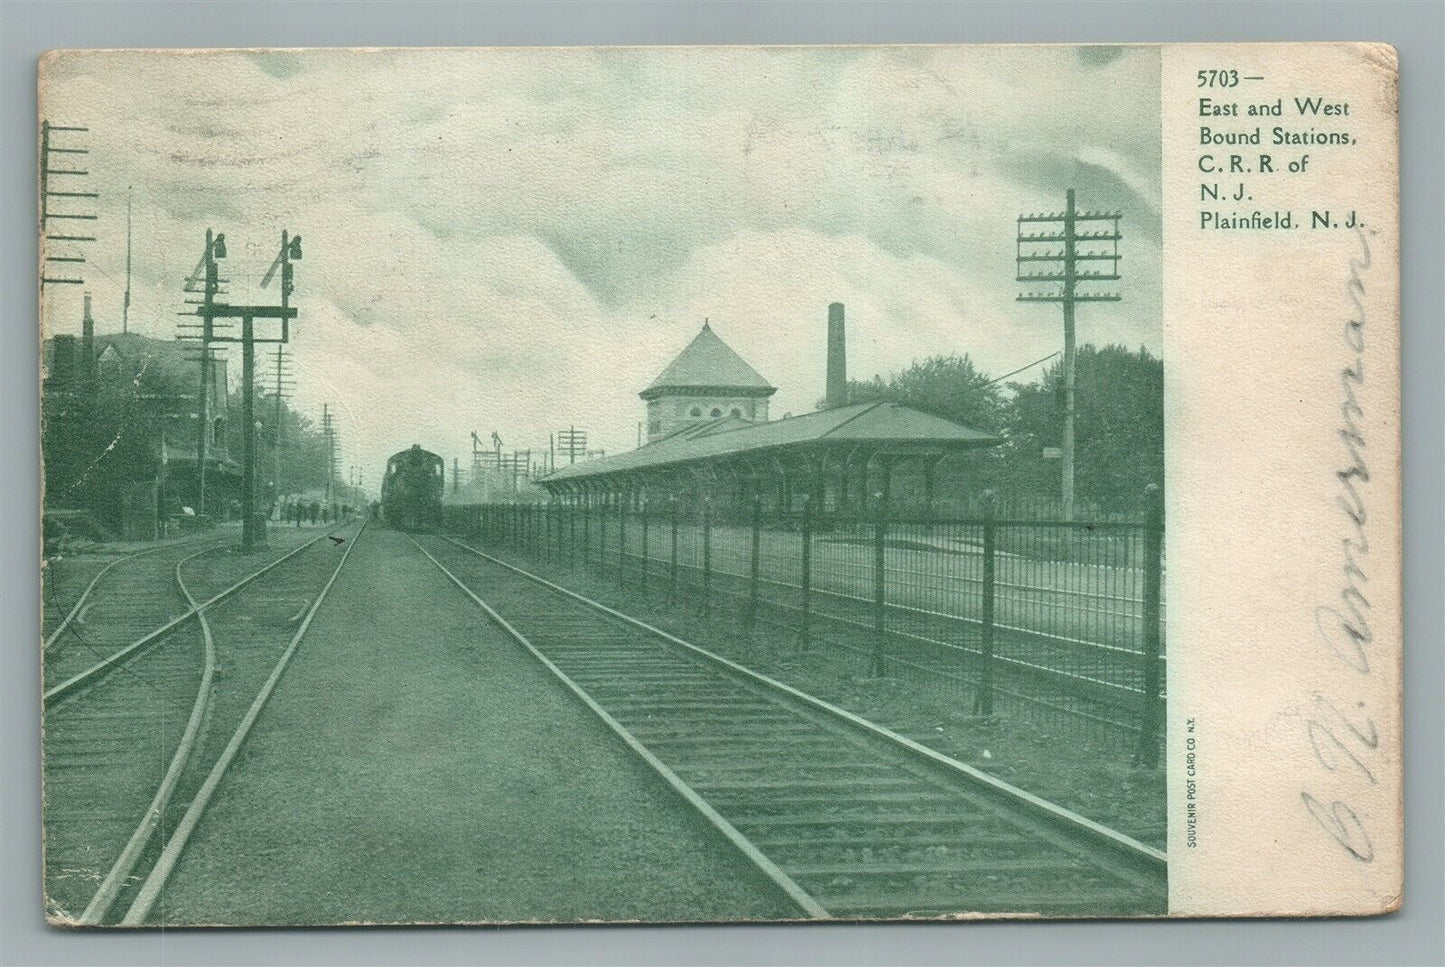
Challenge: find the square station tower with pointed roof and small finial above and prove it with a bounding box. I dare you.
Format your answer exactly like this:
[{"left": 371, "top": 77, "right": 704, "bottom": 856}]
[{"left": 639, "top": 321, "right": 777, "bottom": 442}]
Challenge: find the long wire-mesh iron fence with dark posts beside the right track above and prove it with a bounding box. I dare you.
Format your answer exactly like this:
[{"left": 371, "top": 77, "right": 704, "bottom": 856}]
[{"left": 447, "top": 494, "right": 1166, "bottom": 765}]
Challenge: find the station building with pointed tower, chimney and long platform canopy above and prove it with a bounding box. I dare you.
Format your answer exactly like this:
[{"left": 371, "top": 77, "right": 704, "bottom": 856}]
[{"left": 538, "top": 304, "right": 1001, "bottom": 515}]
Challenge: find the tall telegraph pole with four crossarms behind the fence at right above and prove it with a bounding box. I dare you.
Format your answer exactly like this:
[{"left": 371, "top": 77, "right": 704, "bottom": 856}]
[{"left": 1016, "top": 188, "right": 1123, "bottom": 520}]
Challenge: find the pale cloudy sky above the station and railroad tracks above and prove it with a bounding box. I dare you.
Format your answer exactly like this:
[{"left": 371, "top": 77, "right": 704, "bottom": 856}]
[{"left": 40, "top": 46, "right": 1162, "bottom": 491}]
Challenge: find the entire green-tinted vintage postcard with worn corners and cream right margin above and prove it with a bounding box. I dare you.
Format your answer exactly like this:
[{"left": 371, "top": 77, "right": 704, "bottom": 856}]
[{"left": 36, "top": 43, "right": 1403, "bottom": 927}]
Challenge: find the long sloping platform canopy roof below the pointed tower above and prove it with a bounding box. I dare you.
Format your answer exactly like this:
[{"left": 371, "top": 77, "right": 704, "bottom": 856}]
[{"left": 539, "top": 402, "right": 1000, "bottom": 486}]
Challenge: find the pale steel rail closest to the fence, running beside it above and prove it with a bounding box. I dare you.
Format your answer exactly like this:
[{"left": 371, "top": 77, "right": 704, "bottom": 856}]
[{"left": 442, "top": 535, "right": 1168, "bottom": 877}]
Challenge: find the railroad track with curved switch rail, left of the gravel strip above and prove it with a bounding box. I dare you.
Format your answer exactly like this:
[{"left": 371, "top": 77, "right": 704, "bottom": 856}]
[{"left": 45, "top": 525, "right": 364, "bottom": 925}]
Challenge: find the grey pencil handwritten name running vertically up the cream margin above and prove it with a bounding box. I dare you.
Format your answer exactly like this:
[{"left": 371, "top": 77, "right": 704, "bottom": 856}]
[{"left": 1301, "top": 230, "right": 1380, "bottom": 863}]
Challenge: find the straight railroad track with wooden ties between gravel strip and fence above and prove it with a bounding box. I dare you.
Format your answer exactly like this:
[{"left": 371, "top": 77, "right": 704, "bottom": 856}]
[{"left": 418, "top": 538, "right": 1168, "bottom": 918}]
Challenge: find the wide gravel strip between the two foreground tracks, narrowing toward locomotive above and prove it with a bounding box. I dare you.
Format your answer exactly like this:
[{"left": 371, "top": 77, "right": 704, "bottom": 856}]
[{"left": 153, "top": 525, "right": 796, "bottom": 924}]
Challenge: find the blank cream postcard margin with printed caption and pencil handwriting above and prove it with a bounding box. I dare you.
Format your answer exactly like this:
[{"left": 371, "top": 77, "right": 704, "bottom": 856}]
[{"left": 1160, "top": 43, "right": 1403, "bottom": 916}]
